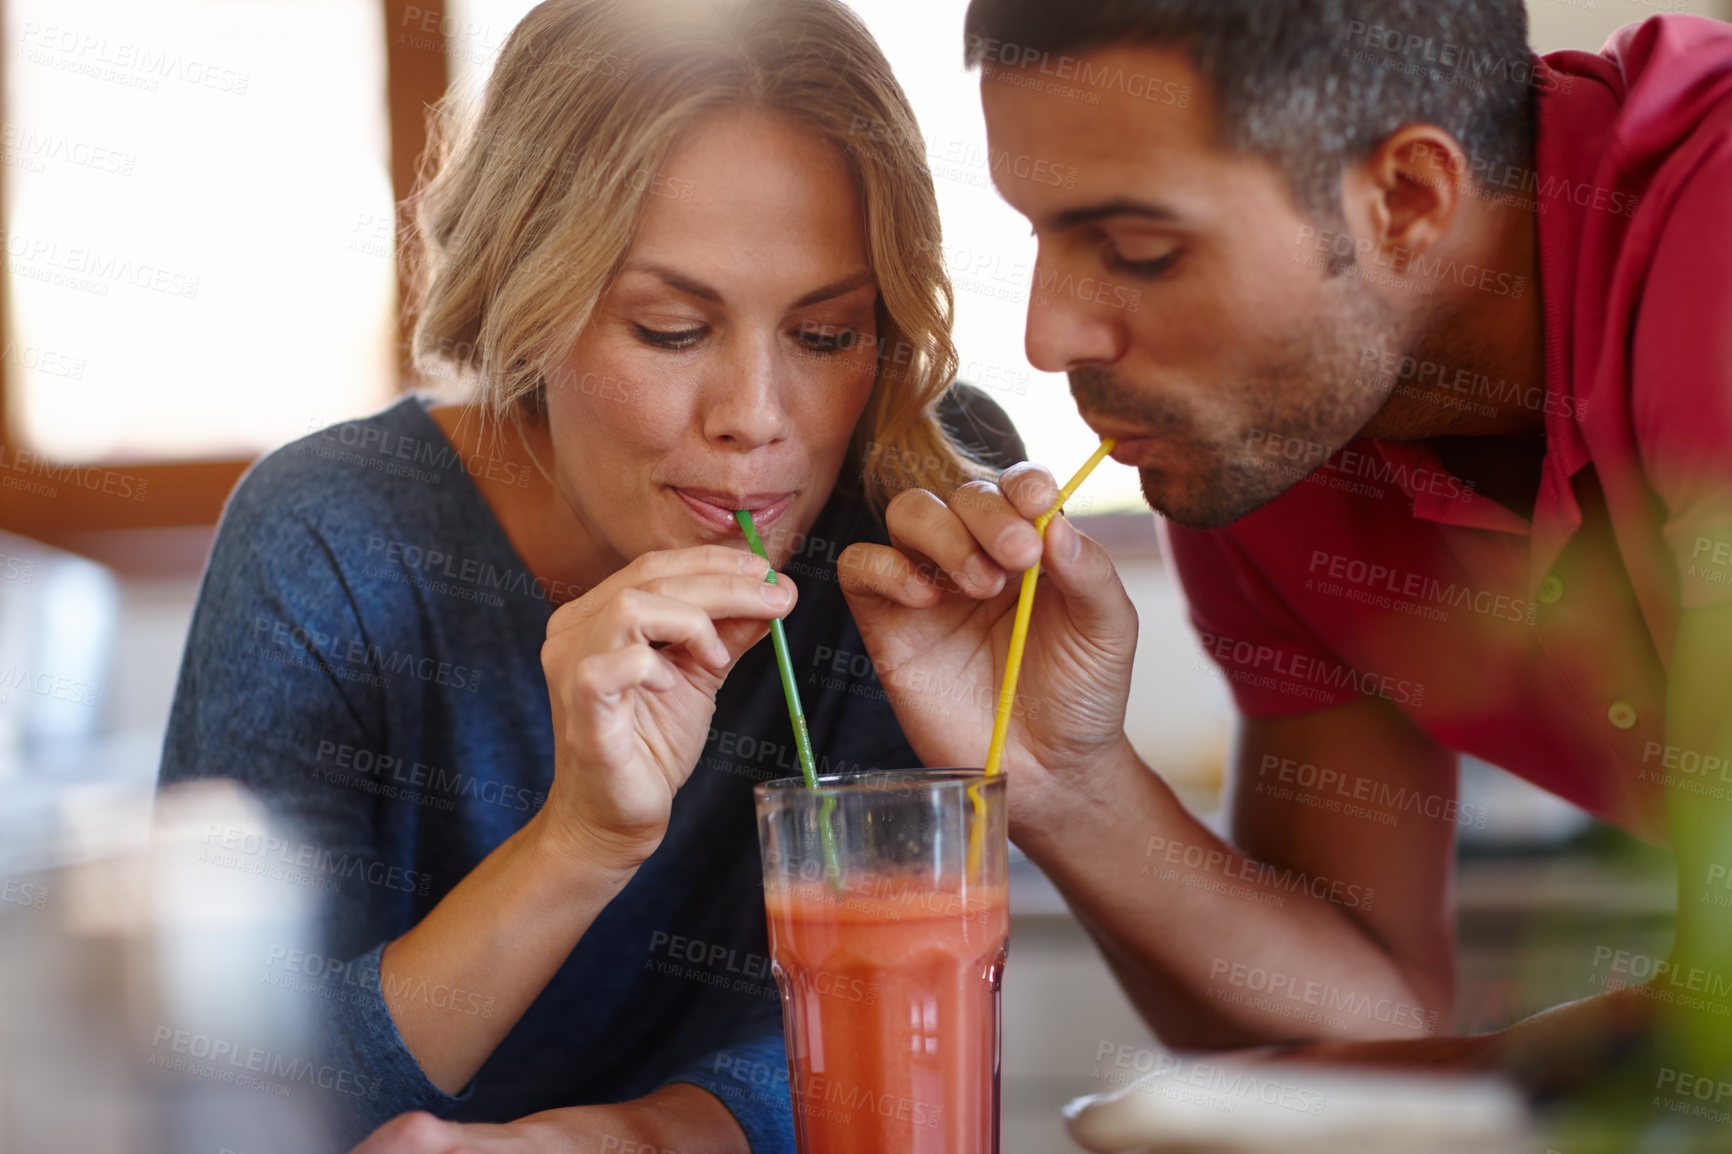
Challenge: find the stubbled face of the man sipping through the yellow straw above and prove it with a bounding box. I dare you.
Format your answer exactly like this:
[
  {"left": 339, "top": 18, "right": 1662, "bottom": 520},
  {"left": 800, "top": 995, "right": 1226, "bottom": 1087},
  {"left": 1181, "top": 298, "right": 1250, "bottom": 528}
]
[{"left": 980, "top": 47, "right": 1398, "bottom": 528}]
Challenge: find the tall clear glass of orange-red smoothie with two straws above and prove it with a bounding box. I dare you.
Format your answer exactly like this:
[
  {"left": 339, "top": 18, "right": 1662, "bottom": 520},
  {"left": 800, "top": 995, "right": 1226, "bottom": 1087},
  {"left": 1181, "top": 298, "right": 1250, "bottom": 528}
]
[{"left": 753, "top": 769, "right": 1010, "bottom": 1154}]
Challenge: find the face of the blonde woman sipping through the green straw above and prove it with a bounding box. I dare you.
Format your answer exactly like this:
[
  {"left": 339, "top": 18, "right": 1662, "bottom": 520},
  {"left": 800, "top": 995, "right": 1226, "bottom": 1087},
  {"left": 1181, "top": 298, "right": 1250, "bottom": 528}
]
[{"left": 547, "top": 111, "right": 878, "bottom": 565}]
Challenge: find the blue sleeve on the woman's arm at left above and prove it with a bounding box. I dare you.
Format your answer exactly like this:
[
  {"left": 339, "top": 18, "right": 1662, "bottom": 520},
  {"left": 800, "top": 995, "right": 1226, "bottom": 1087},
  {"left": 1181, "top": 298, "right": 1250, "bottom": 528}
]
[{"left": 159, "top": 459, "right": 461, "bottom": 1149}]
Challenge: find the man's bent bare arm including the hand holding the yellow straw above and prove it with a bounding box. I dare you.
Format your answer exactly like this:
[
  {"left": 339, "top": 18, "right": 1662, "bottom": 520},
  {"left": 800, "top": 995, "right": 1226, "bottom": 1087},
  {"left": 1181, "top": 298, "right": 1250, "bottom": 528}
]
[{"left": 838, "top": 466, "right": 1453, "bottom": 1047}]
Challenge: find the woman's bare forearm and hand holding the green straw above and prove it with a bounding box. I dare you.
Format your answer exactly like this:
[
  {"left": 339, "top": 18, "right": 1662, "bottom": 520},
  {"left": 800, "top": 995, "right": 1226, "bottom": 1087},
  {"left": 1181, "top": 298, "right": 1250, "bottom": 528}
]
[{"left": 379, "top": 546, "right": 793, "bottom": 1095}]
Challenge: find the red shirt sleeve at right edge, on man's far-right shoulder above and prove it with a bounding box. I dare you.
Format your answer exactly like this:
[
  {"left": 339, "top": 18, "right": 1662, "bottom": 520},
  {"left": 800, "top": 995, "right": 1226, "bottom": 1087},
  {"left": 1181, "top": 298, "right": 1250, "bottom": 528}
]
[{"left": 1630, "top": 139, "right": 1732, "bottom": 608}]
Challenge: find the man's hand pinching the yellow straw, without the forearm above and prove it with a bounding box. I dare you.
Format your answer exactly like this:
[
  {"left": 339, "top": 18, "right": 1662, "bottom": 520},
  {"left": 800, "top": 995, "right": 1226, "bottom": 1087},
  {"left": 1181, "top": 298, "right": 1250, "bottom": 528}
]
[{"left": 838, "top": 464, "right": 1136, "bottom": 828}]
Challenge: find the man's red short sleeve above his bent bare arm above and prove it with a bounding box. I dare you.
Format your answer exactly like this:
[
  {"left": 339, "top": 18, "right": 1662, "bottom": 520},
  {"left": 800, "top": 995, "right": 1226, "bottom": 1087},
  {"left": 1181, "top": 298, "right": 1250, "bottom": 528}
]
[{"left": 1157, "top": 516, "right": 1363, "bottom": 717}]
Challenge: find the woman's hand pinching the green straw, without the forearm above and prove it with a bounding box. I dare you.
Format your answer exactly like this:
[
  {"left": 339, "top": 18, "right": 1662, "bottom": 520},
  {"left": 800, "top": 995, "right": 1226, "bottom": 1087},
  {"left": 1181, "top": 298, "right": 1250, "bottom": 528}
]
[{"left": 537, "top": 546, "right": 797, "bottom": 868}]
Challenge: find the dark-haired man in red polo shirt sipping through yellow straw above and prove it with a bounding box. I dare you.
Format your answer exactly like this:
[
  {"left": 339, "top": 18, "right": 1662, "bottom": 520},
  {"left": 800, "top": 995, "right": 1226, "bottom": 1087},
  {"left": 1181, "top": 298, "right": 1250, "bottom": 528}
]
[{"left": 842, "top": 0, "right": 1732, "bottom": 1115}]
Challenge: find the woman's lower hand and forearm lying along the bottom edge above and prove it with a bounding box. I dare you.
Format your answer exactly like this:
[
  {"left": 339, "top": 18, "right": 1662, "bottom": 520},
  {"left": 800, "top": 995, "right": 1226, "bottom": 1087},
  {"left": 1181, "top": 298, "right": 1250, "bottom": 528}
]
[{"left": 350, "top": 1081, "right": 750, "bottom": 1154}]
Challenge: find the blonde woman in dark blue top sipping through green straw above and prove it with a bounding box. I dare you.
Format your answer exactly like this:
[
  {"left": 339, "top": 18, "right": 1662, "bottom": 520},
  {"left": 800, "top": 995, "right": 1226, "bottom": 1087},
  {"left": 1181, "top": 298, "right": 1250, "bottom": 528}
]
[{"left": 163, "top": 0, "right": 1020, "bottom": 1154}]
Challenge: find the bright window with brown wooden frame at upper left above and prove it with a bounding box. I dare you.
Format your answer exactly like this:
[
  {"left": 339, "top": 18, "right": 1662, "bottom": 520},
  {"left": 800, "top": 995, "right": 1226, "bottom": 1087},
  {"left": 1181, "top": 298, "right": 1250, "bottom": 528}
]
[{"left": 0, "top": 0, "right": 445, "bottom": 560}]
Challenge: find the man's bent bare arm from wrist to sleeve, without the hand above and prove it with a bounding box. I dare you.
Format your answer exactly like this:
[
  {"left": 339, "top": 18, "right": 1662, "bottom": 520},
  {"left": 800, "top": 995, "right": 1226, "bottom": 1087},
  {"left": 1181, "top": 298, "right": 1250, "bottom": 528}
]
[{"left": 1018, "top": 686, "right": 1457, "bottom": 1048}]
